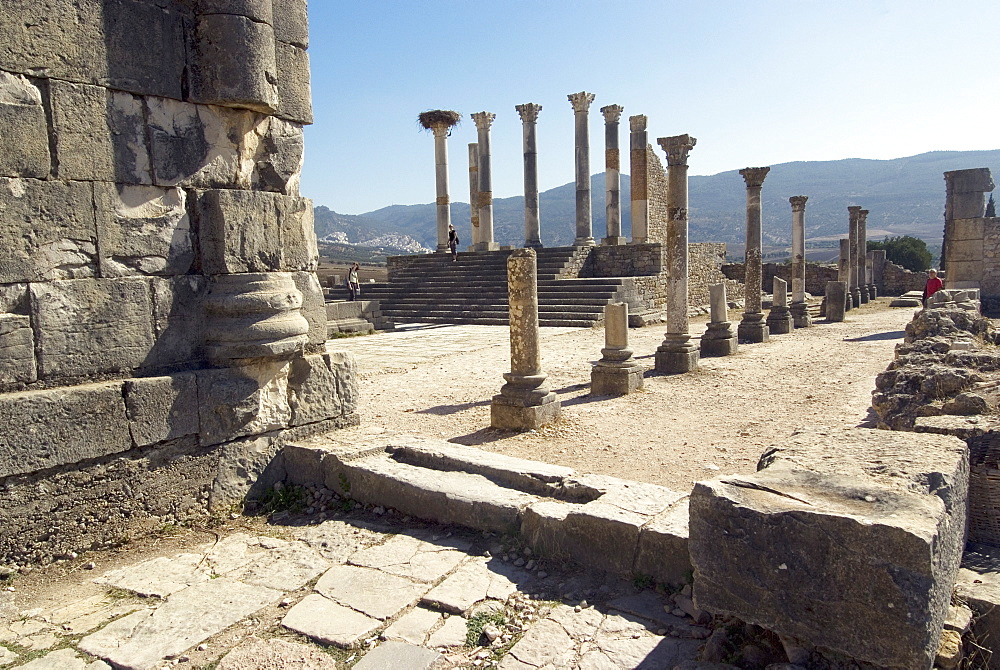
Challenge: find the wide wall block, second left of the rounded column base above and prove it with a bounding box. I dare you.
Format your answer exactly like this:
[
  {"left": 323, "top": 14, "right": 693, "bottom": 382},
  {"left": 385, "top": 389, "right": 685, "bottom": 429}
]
[{"left": 30, "top": 278, "right": 153, "bottom": 379}]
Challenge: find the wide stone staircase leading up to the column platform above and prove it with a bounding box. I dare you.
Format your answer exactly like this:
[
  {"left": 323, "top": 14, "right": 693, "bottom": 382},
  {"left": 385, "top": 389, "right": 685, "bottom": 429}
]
[{"left": 362, "top": 247, "right": 628, "bottom": 328}]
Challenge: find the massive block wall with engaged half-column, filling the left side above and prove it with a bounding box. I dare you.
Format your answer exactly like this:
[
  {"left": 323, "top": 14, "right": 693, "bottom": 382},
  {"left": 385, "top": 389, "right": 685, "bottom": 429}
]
[{"left": 0, "top": 0, "right": 356, "bottom": 563}]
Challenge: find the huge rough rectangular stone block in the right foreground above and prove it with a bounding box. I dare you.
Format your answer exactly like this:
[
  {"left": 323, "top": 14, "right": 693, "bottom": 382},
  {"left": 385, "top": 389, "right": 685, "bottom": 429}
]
[{"left": 690, "top": 429, "right": 969, "bottom": 669}]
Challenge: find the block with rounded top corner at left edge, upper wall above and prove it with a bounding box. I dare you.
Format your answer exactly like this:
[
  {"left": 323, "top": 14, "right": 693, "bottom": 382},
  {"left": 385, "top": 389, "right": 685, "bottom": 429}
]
[{"left": 0, "top": 71, "right": 51, "bottom": 178}]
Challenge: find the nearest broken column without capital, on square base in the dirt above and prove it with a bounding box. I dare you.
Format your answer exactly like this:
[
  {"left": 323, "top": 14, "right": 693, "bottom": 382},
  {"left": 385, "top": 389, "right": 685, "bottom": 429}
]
[{"left": 490, "top": 249, "right": 559, "bottom": 430}]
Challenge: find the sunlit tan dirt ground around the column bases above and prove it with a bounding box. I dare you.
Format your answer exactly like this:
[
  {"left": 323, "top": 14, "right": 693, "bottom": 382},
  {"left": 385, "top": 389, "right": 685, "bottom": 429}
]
[{"left": 336, "top": 298, "right": 914, "bottom": 490}]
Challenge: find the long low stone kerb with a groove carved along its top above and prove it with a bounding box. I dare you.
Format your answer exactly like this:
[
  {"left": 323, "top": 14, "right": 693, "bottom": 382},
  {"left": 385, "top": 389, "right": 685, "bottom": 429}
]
[{"left": 282, "top": 434, "right": 690, "bottom": 584}]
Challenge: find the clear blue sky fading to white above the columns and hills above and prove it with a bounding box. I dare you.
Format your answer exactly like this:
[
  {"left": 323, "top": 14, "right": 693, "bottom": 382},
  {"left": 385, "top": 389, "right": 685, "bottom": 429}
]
[{"left": 302, "top": 0, "right": 1000, "bottom": 214}]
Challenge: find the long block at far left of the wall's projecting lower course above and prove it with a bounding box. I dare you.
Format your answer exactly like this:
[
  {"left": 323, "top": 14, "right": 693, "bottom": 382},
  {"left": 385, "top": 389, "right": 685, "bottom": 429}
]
[{"left": 0, "top": 382, "right": 132, "bottom": 478}]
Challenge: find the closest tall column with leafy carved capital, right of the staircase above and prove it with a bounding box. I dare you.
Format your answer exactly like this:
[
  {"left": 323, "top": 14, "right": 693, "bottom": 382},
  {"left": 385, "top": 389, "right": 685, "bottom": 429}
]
[{"left": 655, "top": 135, "right": 698, "bottom": 374}]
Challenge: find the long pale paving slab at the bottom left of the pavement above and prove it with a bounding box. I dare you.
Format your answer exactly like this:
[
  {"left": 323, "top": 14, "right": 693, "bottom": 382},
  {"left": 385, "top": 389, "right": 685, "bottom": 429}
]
[{"left": 79, "top": 577, "right": 282, "bottom": 670}]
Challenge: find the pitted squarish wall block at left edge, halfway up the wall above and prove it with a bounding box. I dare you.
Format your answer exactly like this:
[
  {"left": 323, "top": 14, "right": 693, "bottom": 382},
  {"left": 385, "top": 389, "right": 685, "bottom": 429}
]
[{"left": 0, "top": 177, "right": 97, "bottom": 283}]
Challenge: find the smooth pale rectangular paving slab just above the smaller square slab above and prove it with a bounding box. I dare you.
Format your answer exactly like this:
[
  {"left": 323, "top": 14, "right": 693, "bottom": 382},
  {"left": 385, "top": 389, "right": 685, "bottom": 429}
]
[{"left": 316, "top": 565, "right": 427, "bottom": 621}]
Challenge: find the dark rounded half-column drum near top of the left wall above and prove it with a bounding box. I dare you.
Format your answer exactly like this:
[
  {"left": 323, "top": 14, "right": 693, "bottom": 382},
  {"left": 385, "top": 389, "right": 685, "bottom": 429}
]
[{"left": 189, "top": 14, "right": 281, "bottom": 114}]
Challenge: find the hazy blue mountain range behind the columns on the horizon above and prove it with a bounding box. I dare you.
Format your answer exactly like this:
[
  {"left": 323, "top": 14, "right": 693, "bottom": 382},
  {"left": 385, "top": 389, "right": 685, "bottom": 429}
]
[{"left": 316, "top": 150, "right": 1000, "bottom": 262}]
